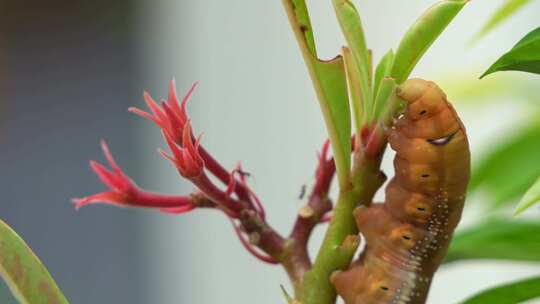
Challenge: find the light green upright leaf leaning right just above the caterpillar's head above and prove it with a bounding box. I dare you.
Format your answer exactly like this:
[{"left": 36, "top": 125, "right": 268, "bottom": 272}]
[{"left": 391, "top": 0, "right": 469, "bottom": 84}]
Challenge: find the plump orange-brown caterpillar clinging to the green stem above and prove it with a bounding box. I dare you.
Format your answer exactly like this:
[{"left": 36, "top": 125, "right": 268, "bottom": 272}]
[{"left": 331, "top": 79, "right": 470, "bottom": 304}]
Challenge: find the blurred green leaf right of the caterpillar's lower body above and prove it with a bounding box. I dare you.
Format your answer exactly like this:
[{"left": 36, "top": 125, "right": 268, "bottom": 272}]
[{"left": 445, "top": 218, "right": 540, "bottom": 262}]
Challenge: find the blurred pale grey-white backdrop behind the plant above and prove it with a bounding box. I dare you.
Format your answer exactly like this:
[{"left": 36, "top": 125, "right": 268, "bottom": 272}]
[{"left": 136, "top": 0, "right": 540, "bottom": 304}]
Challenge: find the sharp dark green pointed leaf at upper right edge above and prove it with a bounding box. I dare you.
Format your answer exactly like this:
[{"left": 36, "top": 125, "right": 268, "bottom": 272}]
[{"left": 480, "top": 27, "right": 540, "bottom": 78}]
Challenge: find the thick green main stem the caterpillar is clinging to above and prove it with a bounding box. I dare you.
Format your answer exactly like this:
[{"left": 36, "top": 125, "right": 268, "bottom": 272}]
[{"left": 297, "top": 154, "right": 384, "bottom": 304}]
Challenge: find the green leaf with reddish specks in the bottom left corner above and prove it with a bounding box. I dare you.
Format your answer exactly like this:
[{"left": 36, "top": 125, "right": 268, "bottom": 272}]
[{"left": 0, "top": 221, "right": 68, "bottom": 304}]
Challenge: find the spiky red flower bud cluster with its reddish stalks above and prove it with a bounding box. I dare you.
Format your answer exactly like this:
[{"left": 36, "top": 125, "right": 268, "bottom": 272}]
[{"left": 73, "top": 80, "right": 279, "bottom": 263}]
